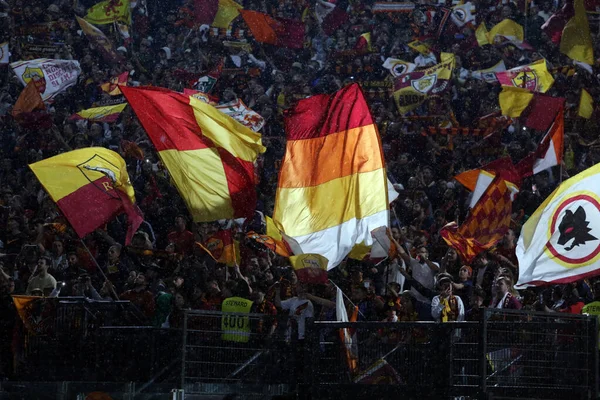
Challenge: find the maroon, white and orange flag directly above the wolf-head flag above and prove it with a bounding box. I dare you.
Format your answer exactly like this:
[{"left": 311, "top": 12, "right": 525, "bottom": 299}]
[{"left": 517, "top": 109, "right": 565, "bottom": 178}]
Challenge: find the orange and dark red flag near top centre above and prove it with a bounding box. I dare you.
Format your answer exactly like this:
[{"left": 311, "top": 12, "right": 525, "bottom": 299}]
[{"left": 240, "top": 10, "right": 304, "bottom": 49}]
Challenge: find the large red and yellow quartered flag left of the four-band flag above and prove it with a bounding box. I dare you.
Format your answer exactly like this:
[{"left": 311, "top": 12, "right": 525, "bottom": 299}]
[{"left": 121, "top": 86, "right": 265, "bottom": 222}]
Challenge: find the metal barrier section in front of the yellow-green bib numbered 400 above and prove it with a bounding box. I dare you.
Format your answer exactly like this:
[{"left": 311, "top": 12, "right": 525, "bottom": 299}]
[{"left": 181, "top": 311, "right": 296, "bottom": 393}]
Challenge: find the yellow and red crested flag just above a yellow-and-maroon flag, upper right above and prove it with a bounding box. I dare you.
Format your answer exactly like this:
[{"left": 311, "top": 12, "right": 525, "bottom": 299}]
[{"left": 496, "top": 59, "right": 554, "bottom": 93}]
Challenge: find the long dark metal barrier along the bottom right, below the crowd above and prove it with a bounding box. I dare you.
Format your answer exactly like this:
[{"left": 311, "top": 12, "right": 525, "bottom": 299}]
[{"left": 307, "top": 309, "right": 598, "bottom": 399}]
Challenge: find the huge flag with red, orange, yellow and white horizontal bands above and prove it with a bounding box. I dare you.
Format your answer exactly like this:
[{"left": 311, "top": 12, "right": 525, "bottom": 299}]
[{"left": 273, "top": 84, "right": 389, "bottom": 270}]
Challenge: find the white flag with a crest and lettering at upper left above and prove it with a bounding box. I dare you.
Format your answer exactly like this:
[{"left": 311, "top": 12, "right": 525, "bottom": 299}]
[{"left": 10, "top": 58, "right": 81, "bottom": 101}]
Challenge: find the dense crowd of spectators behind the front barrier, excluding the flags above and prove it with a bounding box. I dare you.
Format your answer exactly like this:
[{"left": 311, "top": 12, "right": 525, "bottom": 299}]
[{"left": 0, "top": 0, "right": 600, "bottom": 380}]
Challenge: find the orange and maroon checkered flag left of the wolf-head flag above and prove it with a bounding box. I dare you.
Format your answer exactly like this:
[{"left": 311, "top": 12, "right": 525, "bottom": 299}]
[{"left": 440, "top": 175, "right": 512, "bottom": 264}]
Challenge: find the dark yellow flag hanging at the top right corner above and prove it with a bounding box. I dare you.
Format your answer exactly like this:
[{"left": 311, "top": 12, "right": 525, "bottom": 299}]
[{"left": 560, "top": 0, "right": 594, "bottom": 65}]
